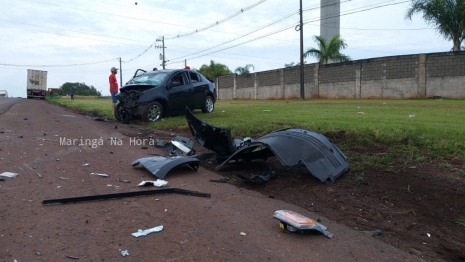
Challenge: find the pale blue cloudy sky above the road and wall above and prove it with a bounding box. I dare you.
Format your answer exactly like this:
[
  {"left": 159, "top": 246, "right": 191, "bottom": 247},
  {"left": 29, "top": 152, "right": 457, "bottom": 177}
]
[{"left": 0, "top": 0, "right": 452, "bottom": 97}]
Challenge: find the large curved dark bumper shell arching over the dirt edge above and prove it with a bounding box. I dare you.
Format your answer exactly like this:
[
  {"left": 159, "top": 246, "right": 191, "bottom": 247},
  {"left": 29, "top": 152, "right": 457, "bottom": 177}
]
[{"left": 216, "top": 128, "right": 349, "bottom": 184}]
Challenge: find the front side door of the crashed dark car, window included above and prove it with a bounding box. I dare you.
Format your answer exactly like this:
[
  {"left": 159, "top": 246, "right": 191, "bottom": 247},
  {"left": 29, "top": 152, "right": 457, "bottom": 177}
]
[{"left": 167, "top": 72, "right": 194, "bottom": 111}]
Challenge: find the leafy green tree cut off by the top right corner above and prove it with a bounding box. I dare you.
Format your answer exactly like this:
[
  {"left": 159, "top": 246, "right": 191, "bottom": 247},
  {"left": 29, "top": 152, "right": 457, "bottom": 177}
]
[{"left": 405, "top": 0, "right": 465, "bottom": 51}]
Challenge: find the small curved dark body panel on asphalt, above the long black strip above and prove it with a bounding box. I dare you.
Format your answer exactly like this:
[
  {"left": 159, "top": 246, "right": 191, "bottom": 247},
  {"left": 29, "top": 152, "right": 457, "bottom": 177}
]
[{"left": 131, "top": 156, "right": 200, "bottom": 179}]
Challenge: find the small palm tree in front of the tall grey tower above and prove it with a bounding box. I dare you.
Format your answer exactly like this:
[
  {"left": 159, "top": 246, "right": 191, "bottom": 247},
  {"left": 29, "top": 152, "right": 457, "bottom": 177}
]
[{"left": 304, "top": 35, "right": 350, "bottom": 64}]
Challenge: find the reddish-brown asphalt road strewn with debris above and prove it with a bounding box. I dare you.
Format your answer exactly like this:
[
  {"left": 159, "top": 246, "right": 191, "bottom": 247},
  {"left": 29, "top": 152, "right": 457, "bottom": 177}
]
[{"left": 0, "top": 99, "right": 421, "bottom": 262}]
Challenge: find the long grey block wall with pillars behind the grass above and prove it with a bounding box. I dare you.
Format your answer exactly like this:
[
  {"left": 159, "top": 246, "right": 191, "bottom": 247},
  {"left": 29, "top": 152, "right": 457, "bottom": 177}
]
[{"left": 215, "top": 51, "right": 465, "bottom": 99}]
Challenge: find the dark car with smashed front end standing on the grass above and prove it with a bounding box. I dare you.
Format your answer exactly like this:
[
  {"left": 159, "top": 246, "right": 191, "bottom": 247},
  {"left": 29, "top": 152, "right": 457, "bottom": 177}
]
[{"left": 115, "top": 69, "right": 216, "bottom": 123}]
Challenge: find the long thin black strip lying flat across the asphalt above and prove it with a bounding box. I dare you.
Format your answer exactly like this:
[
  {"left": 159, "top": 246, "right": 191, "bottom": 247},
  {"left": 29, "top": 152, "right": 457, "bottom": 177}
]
[{"left": 42, "top": 188, "right": 211, "bottom": 205}]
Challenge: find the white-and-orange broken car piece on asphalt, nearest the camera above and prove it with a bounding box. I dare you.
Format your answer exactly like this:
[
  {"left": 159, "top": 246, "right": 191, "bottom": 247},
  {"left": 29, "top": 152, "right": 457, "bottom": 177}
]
[{"left": 273, "top": 210, "right": 333, "bottom": 238}]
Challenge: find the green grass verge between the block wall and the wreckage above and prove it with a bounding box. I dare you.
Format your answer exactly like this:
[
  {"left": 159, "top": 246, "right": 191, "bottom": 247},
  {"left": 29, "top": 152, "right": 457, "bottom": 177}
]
[{"left": 47, "top": 97, "right": 465, "bottom": 178}]
